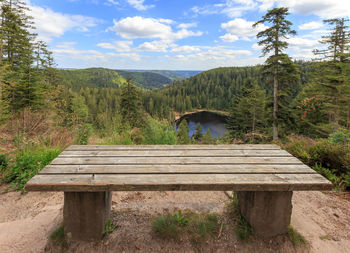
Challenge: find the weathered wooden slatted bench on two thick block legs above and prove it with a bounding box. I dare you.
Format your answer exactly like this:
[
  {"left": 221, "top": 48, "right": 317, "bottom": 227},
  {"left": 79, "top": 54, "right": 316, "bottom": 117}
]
[{"left": 26, "top": 145, "right": 332, "bottom": 241}]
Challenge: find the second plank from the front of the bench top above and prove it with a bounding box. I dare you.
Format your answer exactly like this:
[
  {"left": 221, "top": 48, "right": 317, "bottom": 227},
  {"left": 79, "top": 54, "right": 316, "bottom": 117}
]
[{"left": 39, "top": 164, "right": 317, "bottom": 174}]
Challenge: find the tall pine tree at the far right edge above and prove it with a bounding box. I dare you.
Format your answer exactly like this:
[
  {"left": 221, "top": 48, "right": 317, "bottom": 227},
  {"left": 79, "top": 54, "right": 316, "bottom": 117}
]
[{"left": 313, "top": 18, "right": 350, "bottom": 128}]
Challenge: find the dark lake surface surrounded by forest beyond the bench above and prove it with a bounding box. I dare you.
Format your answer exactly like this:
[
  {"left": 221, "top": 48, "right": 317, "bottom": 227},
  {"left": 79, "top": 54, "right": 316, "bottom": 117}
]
[{"left": 175, "top": 112, "right": 227, "bottom": 138}]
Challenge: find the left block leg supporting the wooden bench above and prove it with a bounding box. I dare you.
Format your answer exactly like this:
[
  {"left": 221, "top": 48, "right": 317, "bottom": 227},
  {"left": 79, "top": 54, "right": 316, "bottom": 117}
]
[{"left": 63, "top": 192, "right": 112, "bottom": 241}]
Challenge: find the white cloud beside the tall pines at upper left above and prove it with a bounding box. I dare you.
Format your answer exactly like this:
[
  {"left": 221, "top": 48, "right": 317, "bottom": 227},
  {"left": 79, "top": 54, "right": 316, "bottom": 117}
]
[{"left": 30, "top": 6, "right": 100, "bottom": 42}]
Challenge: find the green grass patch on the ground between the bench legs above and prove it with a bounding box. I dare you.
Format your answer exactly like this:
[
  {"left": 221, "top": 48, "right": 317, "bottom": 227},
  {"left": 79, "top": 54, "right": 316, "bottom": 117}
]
[{"left": 152, "top": 211, "right": 221, "bottom": 243}]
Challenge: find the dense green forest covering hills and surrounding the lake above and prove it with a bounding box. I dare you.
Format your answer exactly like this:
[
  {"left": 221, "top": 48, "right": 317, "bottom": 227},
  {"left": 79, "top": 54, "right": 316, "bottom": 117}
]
[{"left": 0, "top": 0, "right": 350, "bottom": 192}]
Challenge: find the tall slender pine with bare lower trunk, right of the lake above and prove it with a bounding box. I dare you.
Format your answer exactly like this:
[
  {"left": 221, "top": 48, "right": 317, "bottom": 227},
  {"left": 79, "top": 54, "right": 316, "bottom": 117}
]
[{"left": 253, "top": 8, "right": 296, "bottom": 140}]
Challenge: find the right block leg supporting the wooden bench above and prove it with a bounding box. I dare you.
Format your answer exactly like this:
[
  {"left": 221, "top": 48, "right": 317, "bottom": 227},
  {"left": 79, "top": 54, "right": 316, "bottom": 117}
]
[{"left": 237, "top": 191, "right": 293, "bottom": 237}]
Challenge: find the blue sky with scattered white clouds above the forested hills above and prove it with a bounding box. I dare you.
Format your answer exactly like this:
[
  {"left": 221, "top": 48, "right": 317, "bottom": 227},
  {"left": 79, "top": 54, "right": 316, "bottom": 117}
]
[{"left": 27, "top": 0, "right": 350, "bottom": 70}]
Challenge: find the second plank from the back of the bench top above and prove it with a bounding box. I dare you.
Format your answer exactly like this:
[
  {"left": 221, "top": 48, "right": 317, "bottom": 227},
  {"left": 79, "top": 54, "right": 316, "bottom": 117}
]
[{"left": 60, "top": 149, "right": 292, "bottom": 157}]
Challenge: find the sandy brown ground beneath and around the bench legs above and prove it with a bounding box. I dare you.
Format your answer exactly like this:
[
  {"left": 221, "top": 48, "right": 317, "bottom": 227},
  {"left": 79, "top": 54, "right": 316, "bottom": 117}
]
[{"left": 0, "top": 187, "right": 350, "bottom": 253}]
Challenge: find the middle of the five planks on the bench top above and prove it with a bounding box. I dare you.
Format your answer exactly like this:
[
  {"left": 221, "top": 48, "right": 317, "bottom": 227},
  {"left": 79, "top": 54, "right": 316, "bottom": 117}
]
[{"left": 51, "top": 157, "right": 302, "bottom": 165}]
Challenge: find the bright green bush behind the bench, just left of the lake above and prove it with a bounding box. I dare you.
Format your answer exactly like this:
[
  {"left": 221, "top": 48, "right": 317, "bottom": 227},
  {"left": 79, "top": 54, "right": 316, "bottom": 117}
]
[{"left": 143, "top": 117, "right": 176, "bottom": 145}]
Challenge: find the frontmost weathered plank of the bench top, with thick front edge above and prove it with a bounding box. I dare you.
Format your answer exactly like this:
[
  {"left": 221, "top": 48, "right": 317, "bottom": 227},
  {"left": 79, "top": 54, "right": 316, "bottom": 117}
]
[{"left": 26, "top": 174, "right": 332, "bottom": 191}]
